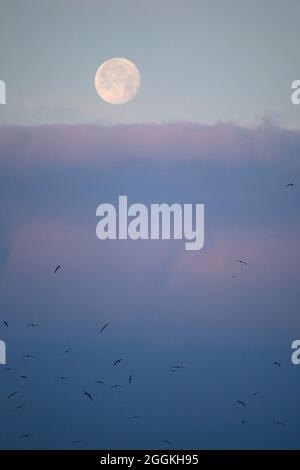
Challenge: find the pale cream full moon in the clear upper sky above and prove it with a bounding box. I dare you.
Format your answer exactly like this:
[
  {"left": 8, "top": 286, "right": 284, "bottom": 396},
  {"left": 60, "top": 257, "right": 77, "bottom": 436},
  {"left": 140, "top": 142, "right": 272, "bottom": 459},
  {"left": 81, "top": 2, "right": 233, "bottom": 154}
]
[{"left": 95, "top": 58, "right": 141, "bottom": 104}]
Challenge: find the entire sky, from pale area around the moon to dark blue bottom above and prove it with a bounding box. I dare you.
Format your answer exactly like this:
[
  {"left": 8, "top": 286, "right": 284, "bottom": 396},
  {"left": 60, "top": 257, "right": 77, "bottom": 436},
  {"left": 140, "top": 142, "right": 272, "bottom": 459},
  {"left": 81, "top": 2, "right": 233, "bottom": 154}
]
[{"left": 0, "top": 0, "right": 300, "bottom": 449}]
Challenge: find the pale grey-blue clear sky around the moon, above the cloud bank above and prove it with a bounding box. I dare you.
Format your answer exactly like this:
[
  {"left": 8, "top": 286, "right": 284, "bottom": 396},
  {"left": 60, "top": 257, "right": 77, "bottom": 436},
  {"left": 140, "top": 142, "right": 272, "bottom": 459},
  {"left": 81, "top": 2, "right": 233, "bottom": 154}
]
[{"left": 0, "top": 0, "right": 300, "bottom": 128}]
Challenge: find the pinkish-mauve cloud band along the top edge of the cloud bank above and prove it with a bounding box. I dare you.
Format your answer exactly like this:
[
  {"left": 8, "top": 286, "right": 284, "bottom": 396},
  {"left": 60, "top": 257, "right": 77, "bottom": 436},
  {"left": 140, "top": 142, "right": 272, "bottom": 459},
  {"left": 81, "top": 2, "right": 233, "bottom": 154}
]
[{"left": 0, "top": 124, "right": 300, "bottom": 166}]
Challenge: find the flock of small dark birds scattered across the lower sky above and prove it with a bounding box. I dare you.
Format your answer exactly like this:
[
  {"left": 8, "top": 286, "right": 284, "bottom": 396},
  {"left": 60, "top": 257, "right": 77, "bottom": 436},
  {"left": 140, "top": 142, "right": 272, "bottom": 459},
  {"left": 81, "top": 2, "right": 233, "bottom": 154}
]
[{"left": 2, "top": 183, "right": 294, "bottom": 446}]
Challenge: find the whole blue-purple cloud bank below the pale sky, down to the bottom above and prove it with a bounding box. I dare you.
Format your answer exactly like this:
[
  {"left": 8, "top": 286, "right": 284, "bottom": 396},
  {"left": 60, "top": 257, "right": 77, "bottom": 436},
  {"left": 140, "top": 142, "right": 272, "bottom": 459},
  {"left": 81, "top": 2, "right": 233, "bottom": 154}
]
[{"left": 0, "top": 125, "right": 300, "bottom": 449}]
